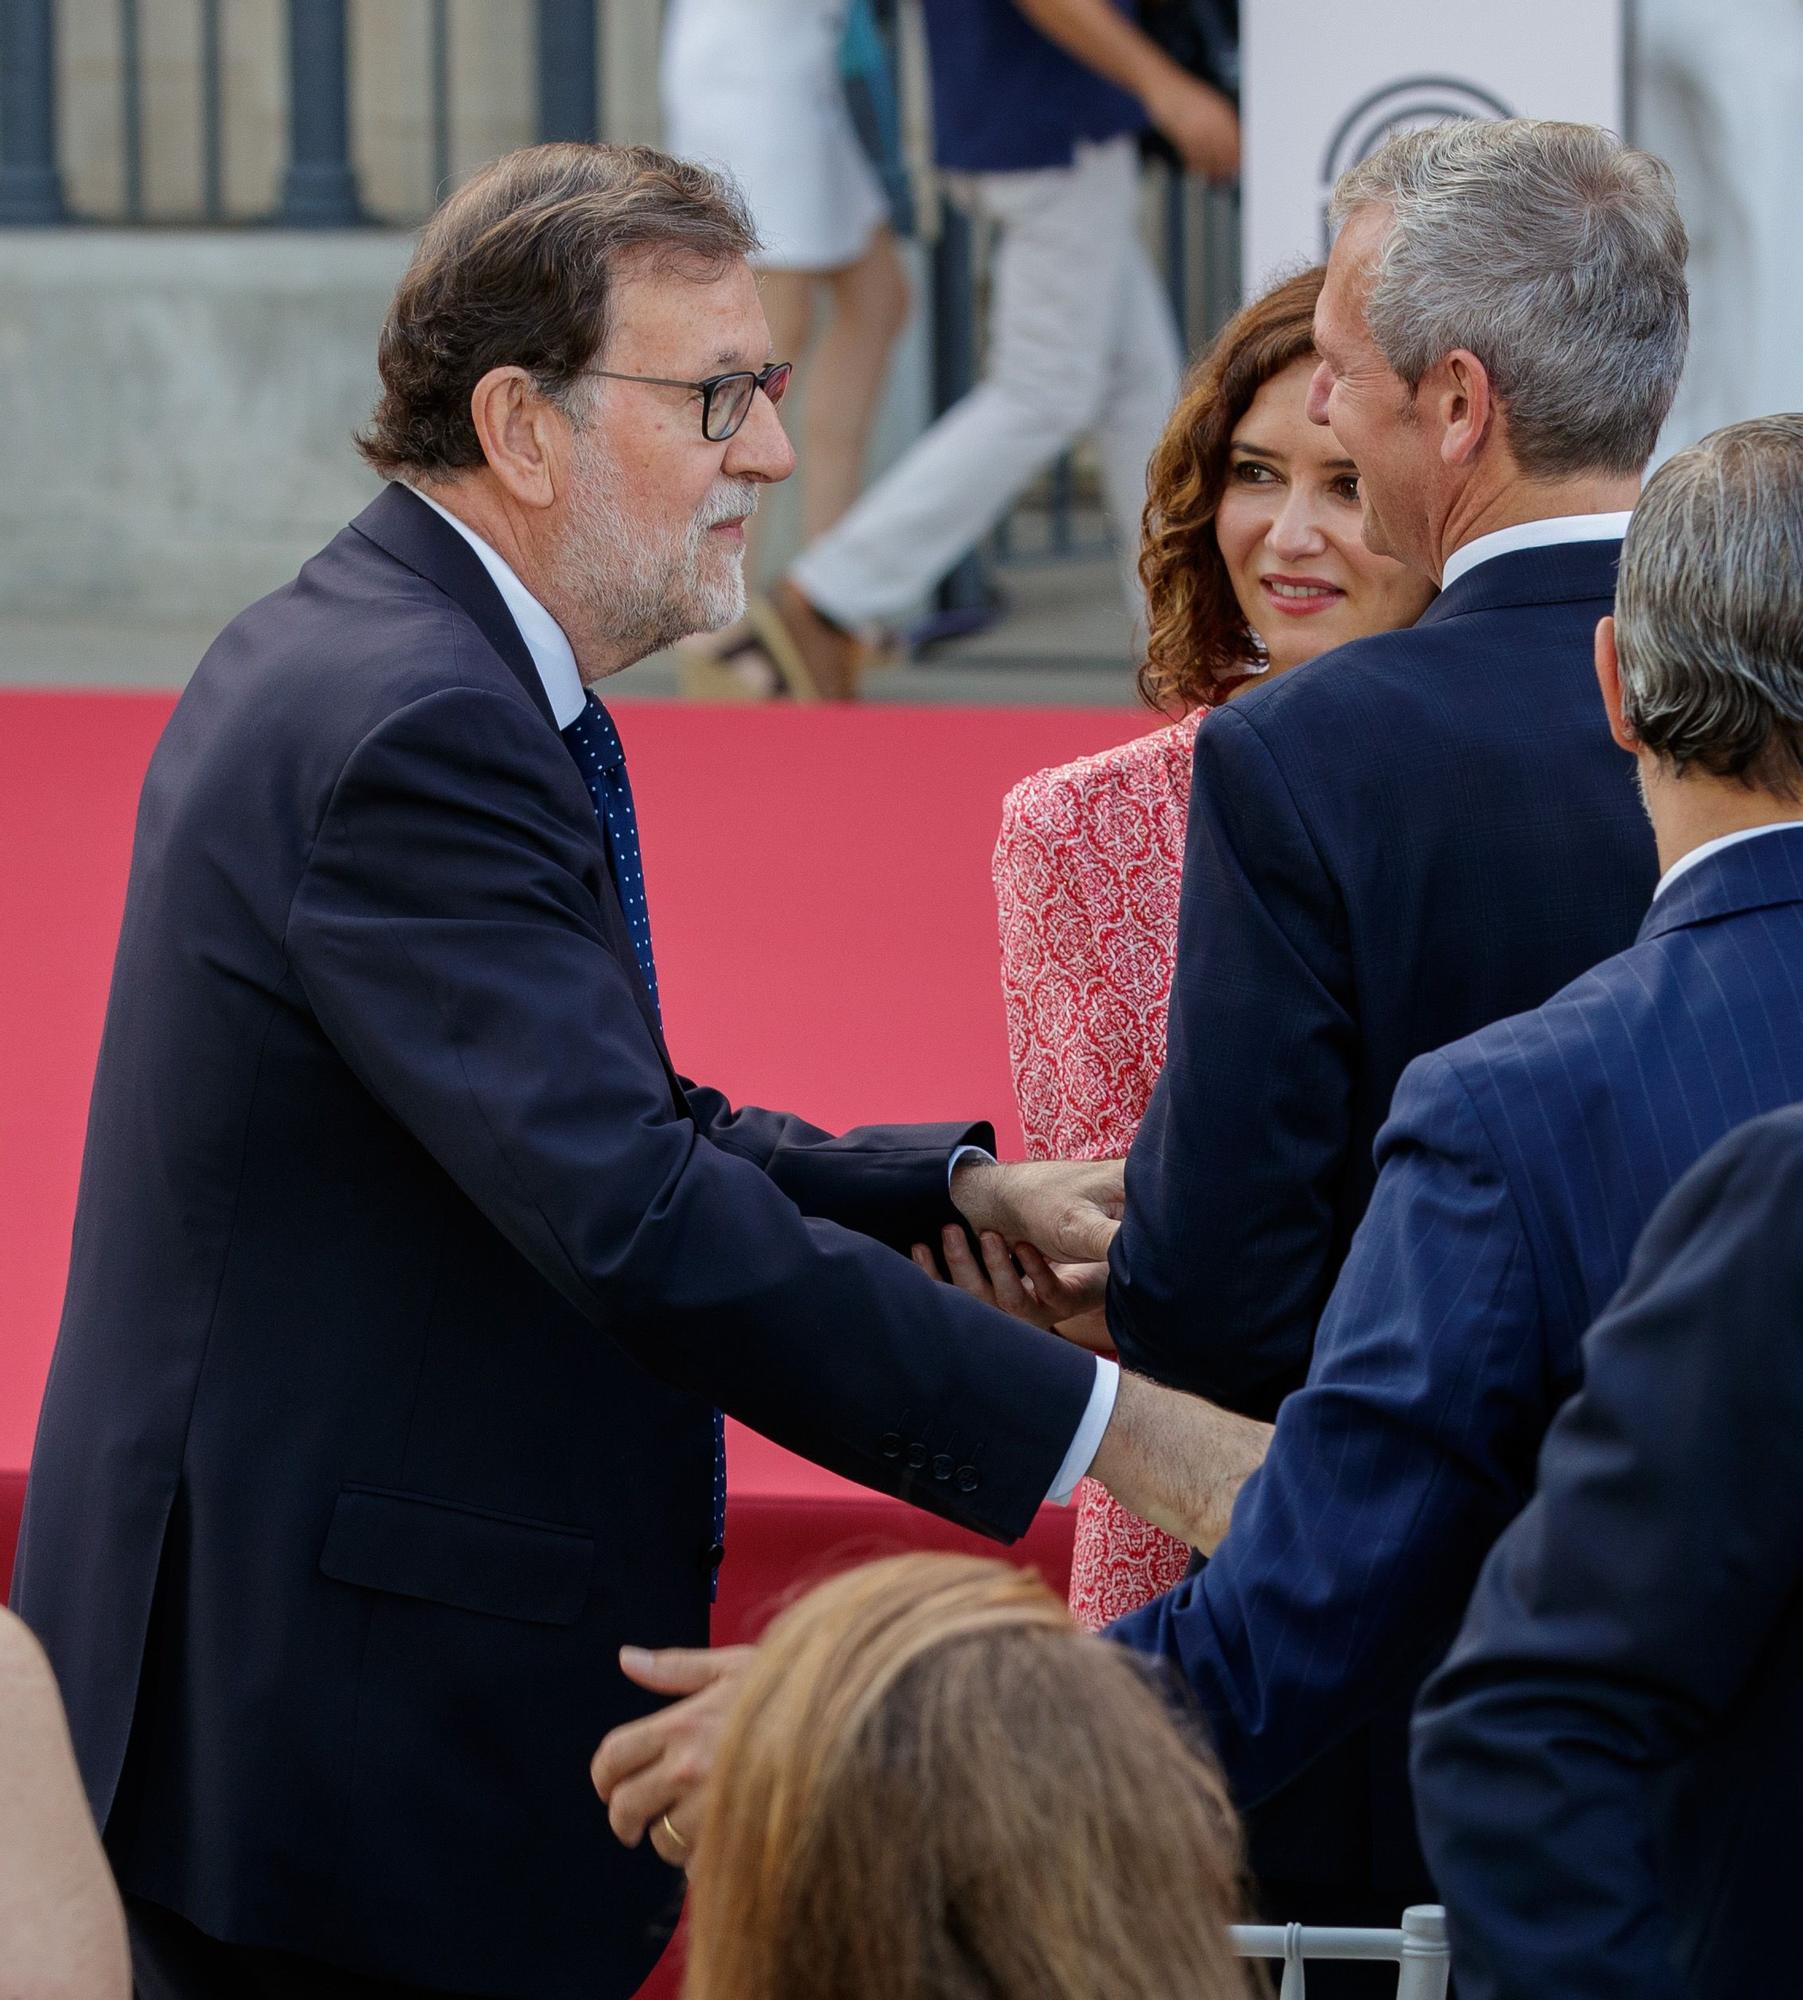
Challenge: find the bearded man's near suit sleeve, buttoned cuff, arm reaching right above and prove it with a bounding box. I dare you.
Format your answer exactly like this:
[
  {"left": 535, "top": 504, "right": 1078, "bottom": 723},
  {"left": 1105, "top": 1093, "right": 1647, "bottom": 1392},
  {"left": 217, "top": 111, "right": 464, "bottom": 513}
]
[{"left": 286, "top": 690, "right": 1095, "bottom": 1538}]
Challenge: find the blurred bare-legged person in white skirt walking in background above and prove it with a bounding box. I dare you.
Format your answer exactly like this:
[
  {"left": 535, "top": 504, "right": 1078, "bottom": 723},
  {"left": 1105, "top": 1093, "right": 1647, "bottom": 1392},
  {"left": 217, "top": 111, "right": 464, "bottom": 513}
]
[{"left": 662, "top": 0, "right": 907, "bottom": 700}]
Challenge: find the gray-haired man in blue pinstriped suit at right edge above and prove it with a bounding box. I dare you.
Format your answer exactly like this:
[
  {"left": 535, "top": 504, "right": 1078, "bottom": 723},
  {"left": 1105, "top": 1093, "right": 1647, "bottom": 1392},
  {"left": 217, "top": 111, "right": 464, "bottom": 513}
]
[{"left": 1111, "top": 416, "right": 1803, "bottom": 1904}]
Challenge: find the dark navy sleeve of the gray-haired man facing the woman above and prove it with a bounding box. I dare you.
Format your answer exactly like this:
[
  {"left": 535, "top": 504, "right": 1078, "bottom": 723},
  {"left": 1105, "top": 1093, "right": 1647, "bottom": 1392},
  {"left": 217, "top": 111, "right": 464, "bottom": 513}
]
[{"left": 1107, "top": 708, "right": 1355, "bottom": 1418}]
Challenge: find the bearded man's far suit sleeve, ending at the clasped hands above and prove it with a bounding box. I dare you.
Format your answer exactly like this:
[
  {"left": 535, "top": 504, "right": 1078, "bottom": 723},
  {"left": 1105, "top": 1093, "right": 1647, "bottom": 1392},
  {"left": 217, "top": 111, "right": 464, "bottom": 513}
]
[{"left": 682, "top": 1078, "right": 995, "bottom": 1250}]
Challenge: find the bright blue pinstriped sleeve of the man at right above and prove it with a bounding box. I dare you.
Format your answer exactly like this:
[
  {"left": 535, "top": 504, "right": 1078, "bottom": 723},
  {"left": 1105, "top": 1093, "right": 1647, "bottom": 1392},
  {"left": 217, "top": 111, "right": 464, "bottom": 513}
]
[{"left": 1109, "top": 1056, "right": 1545, "bottom": 1806}]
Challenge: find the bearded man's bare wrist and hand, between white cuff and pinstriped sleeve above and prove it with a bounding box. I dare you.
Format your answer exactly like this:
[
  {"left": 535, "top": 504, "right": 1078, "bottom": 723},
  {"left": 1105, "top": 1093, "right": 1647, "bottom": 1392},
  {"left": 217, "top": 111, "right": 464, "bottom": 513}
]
[{"left": 1089, "top": 1370, "right": 1271, "bottom": 1552}]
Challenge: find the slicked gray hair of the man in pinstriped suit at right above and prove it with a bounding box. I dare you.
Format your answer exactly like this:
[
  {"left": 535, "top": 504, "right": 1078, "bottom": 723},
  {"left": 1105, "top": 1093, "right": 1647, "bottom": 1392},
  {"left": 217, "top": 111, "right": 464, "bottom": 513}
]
[{"left": 1615, "top": 414, "right": 1803, "bottom": 798}]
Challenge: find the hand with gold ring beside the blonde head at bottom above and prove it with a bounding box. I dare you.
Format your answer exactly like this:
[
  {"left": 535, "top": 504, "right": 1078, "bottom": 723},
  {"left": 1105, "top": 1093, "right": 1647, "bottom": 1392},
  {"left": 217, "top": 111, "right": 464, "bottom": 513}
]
[{"left": 590, "top": 1646, "right": 752, "bottom": 1868}]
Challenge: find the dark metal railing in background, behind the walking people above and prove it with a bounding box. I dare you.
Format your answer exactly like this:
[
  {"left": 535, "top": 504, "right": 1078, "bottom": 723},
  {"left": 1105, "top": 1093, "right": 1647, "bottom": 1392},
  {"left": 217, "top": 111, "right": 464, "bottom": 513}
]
[{"left": 0, "top": 0, "right": 1239, "bottom": 608}]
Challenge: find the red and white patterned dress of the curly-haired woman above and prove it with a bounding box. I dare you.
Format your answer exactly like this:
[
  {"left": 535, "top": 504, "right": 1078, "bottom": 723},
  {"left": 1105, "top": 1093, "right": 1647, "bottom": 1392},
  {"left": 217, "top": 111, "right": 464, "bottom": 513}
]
[{"left": 995, "top": 710, "right": 1205, "bottom": 1630}]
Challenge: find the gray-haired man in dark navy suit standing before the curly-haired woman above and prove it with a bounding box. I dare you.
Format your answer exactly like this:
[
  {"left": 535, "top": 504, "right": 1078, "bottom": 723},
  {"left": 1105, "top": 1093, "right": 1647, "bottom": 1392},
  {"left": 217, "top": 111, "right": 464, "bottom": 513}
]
[{"left": 1107, "top": 120, "right": 1687, "bottom": 1952}]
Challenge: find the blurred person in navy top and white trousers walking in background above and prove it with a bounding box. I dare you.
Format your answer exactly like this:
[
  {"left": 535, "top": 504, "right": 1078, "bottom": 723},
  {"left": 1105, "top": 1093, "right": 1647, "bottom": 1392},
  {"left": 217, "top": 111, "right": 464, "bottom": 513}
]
[{"left": 723, "top": 0, "right": 1239, "bottom": 698}]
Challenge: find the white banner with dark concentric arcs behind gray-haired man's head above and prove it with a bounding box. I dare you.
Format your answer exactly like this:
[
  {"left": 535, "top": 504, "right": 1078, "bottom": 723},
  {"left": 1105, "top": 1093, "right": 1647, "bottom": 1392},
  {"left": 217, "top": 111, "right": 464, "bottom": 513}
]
[{"left": 1241, "top": 0, "right": 1627, "bottom": 298}]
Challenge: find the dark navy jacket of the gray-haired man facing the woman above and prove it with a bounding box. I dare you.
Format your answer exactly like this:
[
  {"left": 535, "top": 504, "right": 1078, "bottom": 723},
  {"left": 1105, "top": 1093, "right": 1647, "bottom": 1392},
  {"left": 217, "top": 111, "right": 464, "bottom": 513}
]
[{"left": 1107, "top": 542, "right": 1657, "bottom": 1418}]
